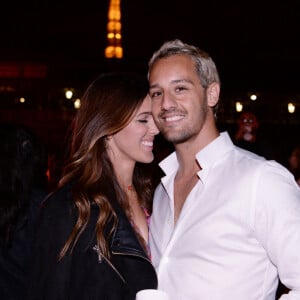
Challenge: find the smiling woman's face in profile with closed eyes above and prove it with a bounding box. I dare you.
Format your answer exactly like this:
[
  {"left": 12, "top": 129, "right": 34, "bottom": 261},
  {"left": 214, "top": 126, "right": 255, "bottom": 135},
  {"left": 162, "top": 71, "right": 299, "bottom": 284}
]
[{"left": 108, "top": 96, "right": 159, "bottom": 165}]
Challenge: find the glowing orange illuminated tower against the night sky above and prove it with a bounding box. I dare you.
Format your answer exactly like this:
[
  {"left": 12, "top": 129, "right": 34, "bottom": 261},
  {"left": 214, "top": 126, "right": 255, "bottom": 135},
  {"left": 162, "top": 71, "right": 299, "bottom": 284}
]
[{"left": 105, "top": 0, "right": 123, "bottom": 59}]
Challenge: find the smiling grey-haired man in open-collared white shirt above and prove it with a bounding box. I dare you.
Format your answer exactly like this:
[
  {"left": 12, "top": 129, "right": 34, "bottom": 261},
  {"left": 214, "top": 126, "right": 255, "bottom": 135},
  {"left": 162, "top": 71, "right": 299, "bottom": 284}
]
[{"left": 148, "top": 40, "right": 300, "bottom": 300}]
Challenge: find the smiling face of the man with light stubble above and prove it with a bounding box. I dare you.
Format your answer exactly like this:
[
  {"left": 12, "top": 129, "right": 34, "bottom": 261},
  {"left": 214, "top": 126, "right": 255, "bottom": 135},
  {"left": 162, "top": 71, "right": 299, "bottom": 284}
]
[{"left": 149, "top": 54, "right": 209, "bottom": 144}]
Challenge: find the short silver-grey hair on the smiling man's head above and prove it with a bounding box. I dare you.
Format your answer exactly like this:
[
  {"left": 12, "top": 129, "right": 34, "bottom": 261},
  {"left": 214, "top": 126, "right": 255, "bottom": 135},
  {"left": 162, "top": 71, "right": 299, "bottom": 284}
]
[{"left": 148, "top": 39, "right": 221, "bottom": 88}]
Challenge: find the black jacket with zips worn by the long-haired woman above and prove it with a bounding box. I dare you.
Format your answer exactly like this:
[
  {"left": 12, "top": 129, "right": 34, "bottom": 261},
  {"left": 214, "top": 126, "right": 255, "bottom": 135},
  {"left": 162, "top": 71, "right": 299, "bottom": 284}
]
[{"left": 28, "top": 186, "right": 157, "bottom": 300}]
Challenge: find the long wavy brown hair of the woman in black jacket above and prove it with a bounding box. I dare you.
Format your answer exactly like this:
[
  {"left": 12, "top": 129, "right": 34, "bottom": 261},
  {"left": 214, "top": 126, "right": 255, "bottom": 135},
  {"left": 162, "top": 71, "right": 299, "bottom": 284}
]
[{"left": 59, "top": 73, "right": 152, "bottom": 259}]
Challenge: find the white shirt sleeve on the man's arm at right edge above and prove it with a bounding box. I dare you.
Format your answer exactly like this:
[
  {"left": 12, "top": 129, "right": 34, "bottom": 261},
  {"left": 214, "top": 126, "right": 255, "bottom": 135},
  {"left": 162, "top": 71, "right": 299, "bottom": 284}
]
[{"left": 254, "top": 162, "right": 300, "bottom": 300}]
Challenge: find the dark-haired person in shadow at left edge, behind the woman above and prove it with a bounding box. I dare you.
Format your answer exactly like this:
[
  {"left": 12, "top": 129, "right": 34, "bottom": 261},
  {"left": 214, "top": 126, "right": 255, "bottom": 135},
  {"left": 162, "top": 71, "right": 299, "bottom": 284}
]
[{"left": 0, "top": 123, "right": 47, "bottom": 300}]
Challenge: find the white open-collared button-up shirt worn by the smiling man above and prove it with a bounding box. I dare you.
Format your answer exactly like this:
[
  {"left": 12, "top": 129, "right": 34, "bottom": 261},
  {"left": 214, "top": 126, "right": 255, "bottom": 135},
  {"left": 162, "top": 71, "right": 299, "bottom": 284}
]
[{"left": 150, "top": 132, "right": 300, "bottom": 300}]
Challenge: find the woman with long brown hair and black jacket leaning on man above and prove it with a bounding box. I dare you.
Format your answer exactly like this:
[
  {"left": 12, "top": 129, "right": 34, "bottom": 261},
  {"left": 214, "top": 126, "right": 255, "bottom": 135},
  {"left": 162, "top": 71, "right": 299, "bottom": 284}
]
[{"left": 29, "top": 73, "right": 158, "bottom": 300}]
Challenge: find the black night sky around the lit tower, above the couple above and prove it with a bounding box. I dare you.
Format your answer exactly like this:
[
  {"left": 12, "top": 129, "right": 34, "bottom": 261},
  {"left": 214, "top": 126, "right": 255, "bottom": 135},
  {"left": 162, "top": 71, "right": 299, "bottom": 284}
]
[{"left": 0, "top": 0, "right": 300, "bottom": 92}]
